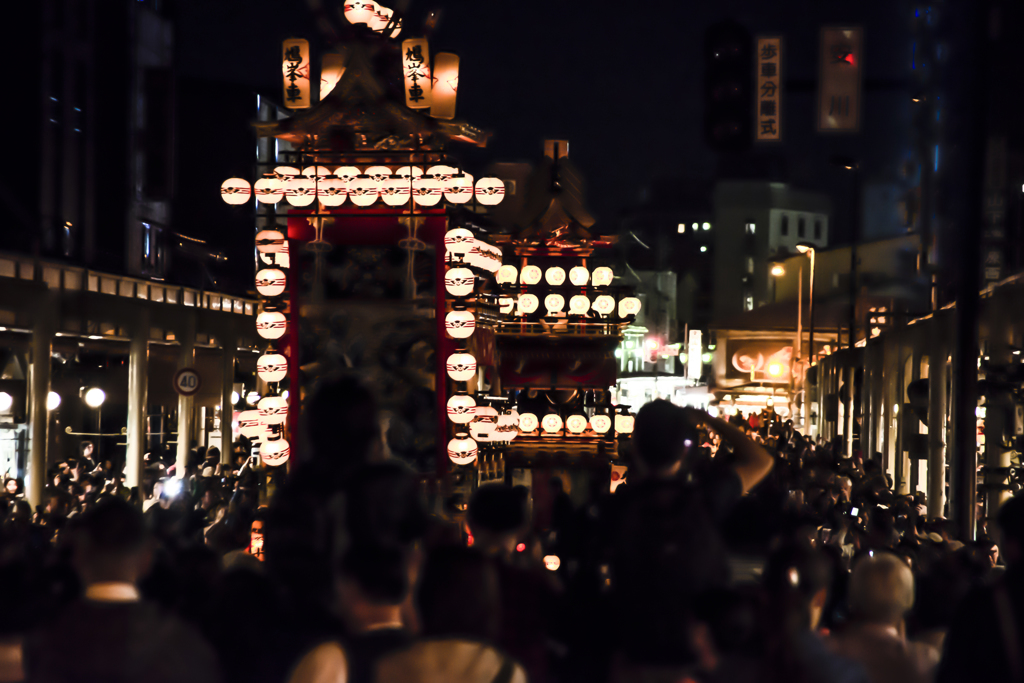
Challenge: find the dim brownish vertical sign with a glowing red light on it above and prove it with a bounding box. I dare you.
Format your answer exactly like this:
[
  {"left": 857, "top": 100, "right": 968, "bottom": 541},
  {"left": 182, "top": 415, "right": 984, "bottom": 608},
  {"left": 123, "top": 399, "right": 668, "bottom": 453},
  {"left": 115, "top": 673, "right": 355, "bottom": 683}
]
[{"left": 818, "top": 27, "right": 864, "bottom": 133}]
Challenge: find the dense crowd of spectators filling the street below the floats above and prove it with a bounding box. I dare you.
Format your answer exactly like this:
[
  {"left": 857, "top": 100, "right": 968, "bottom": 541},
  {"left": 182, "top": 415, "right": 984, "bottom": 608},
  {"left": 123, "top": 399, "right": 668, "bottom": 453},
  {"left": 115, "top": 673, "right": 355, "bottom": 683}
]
[{"left": 0, "top": 379, "right": 1024, "bottom": 683}]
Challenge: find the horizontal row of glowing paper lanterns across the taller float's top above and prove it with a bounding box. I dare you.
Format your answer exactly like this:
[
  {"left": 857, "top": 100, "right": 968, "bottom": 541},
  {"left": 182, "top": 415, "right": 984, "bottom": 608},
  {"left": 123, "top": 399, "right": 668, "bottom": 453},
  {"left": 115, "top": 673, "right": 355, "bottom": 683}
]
[{"left": 220, "top": 166, "right": 505, "bottom": 207}]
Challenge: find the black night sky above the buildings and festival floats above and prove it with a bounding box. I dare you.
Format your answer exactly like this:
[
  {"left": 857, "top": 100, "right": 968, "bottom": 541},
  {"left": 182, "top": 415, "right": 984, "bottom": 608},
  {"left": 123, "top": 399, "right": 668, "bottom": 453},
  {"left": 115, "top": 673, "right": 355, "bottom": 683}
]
[{"left": 177, "top": 0, "right": 912, "bottom": 233}]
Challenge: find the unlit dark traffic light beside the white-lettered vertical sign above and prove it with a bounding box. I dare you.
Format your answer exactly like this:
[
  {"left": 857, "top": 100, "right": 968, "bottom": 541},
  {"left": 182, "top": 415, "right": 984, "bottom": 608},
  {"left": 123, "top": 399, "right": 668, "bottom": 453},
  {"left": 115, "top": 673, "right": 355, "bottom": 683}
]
[{"left": 705, "top": 19, "right": 754, "bottom": 152}]
